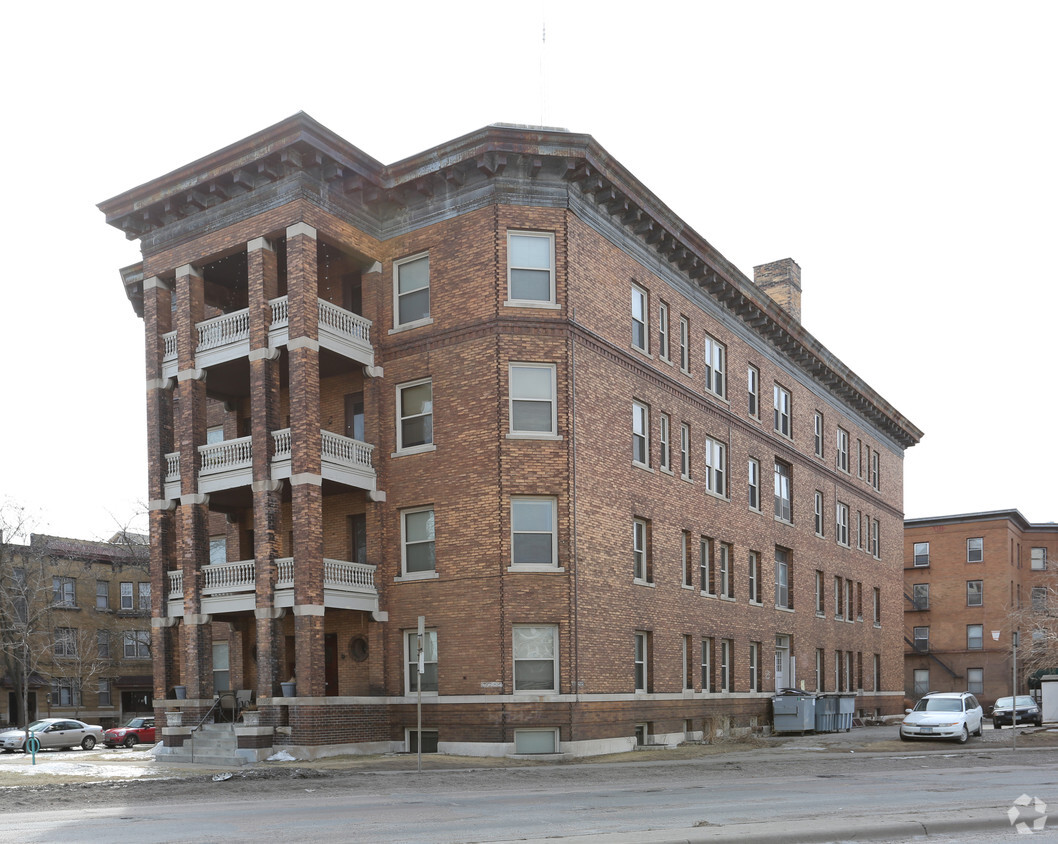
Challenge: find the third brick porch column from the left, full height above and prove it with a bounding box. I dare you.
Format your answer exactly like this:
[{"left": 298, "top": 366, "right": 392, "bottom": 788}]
[{"left": 247, "top": 237, "right": 287, "bottom": 697}]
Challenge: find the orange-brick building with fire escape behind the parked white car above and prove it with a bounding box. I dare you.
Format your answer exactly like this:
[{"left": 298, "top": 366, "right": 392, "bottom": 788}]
[{"left": 904, "top": 510, "right": 1058, "bottom": 707}]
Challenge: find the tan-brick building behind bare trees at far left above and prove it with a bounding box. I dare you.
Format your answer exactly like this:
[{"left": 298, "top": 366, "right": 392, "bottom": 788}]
[{"left": 0, "top": 534, "right": 152, "bottom": 727}]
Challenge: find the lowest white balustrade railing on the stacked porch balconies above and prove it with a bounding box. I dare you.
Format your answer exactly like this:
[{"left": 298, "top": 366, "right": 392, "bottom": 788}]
[{"left": 167, "top": 556, "right": 379, "bottom": 616}]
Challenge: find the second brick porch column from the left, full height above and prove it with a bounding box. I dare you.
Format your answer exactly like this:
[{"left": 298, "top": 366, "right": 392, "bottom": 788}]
[{"left": 176, "top": 264, "right": 213, "bottom": 698}]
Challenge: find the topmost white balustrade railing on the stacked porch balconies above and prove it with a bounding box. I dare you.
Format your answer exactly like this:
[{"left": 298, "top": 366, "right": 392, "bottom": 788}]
[{"left": 156, "top": 296, "right": 375, "bottom": 378}]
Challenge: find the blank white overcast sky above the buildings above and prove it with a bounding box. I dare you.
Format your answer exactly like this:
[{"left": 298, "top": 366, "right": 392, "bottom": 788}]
[{"left": 0, "top": 0, "right": 1058, "bottom": 538}]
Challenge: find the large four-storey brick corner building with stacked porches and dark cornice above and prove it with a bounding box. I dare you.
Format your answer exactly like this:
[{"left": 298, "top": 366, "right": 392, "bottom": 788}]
[{"left": 101, "top": 114, "right": 920, "bottom": 754}]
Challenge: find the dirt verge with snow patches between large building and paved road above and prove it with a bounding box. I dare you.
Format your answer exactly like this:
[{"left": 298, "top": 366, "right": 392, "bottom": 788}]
[{"left": 0, "top": 727, "right": 1058, "bottom": 813}]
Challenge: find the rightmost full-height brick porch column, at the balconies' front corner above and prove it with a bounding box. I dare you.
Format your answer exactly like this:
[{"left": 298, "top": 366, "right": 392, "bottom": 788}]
[{"left": 287, "top": 223, "right": 326, "bottom": 697}]
